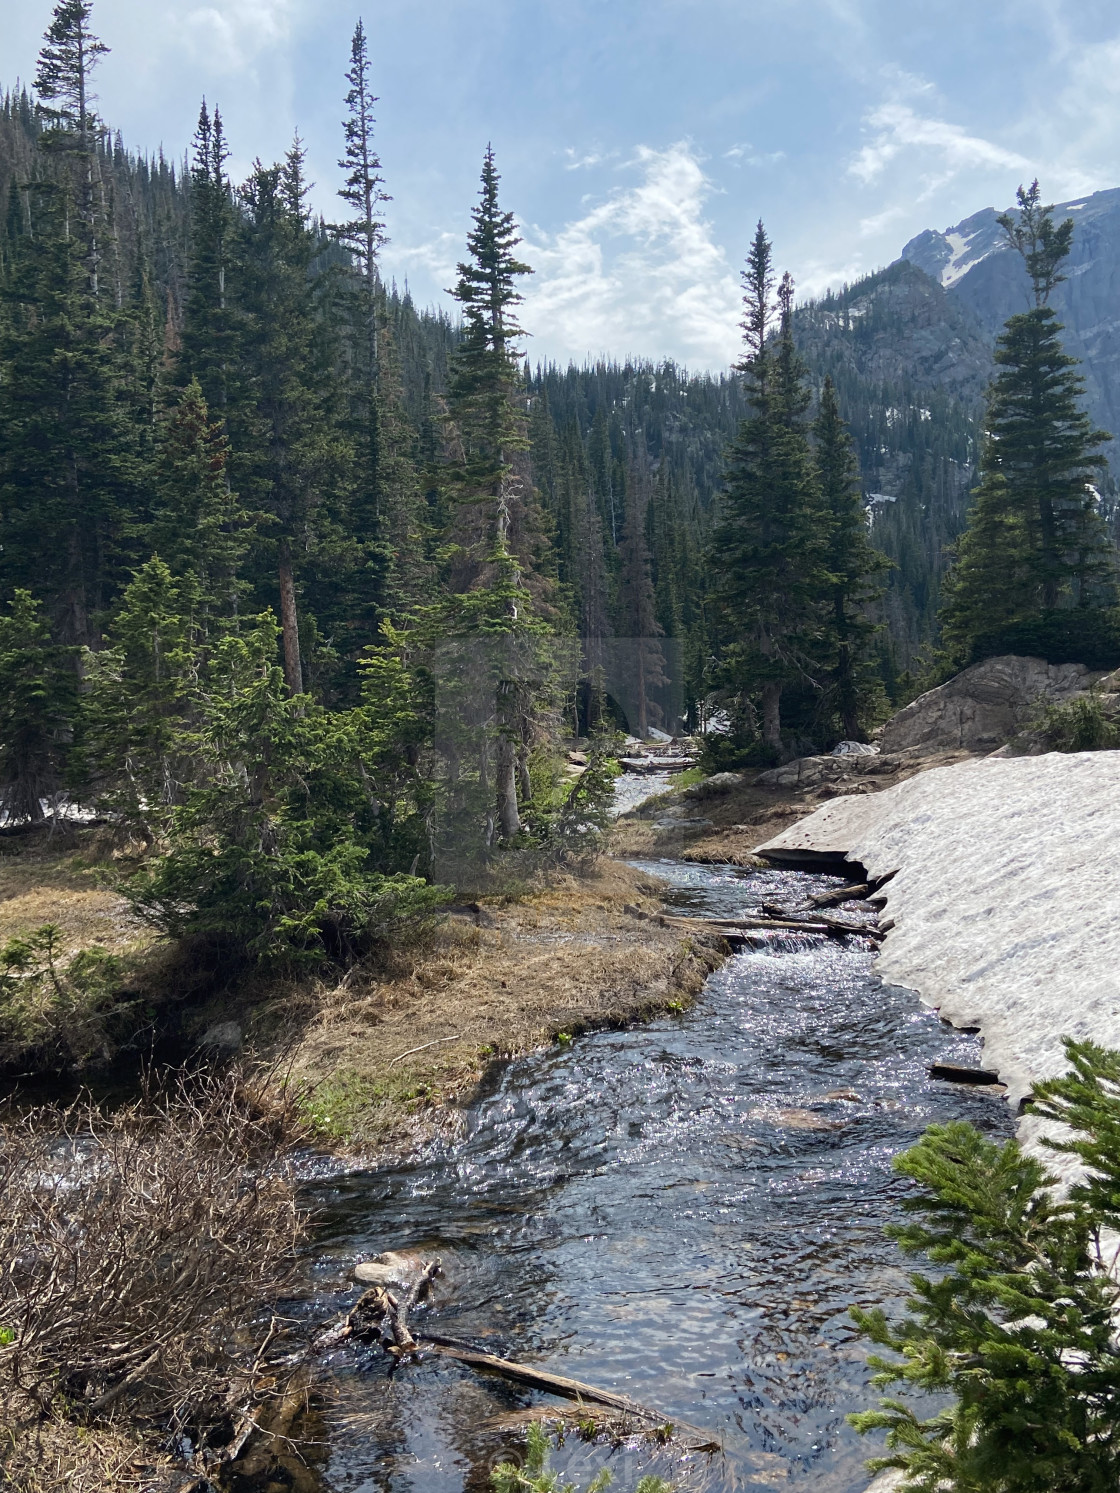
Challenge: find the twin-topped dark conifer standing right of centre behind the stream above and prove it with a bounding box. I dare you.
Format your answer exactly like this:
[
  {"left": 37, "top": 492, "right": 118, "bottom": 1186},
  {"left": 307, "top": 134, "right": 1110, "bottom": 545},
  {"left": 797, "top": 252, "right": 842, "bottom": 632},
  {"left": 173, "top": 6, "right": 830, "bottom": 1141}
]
[{"left": 711, "top": 224, "right": 827, "bottom": 754}]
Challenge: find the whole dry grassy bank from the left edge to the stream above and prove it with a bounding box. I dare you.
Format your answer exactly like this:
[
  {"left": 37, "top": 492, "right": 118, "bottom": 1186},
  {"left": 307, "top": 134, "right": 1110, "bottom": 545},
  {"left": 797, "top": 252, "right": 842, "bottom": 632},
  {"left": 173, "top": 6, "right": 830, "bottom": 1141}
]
[{"left": 0, "top": 830, "right": 720, "bottom": 1154}]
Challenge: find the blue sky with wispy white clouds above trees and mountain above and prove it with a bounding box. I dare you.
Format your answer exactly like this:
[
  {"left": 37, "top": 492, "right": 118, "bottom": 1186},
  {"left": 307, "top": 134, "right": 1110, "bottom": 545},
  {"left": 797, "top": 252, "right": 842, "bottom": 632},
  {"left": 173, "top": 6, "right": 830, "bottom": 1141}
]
[{"left": 0, "top": 0, "right": 1120, "bottom": 369}]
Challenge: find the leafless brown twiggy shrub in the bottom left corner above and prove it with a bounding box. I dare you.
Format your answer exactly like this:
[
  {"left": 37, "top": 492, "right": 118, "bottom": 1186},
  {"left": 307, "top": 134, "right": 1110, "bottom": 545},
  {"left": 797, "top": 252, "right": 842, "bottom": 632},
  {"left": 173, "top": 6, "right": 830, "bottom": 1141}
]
[{"left": 0, "top": 1073, "right": 303, "bottom": 1430}]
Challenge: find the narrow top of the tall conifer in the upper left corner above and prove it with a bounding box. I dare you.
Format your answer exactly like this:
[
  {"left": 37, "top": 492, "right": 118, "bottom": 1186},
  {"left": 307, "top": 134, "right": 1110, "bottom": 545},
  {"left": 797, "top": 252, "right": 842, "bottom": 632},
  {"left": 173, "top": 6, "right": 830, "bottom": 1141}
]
[{"left": 34, "top": 0, "right": 109, "bottom": 299}]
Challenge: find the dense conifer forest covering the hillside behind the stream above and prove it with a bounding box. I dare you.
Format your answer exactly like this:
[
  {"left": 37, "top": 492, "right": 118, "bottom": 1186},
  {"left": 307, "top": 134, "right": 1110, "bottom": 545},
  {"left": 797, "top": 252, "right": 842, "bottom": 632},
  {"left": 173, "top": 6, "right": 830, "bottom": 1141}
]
[{"left": 0, "top": 0, "right": 1111, "bottom": 953}]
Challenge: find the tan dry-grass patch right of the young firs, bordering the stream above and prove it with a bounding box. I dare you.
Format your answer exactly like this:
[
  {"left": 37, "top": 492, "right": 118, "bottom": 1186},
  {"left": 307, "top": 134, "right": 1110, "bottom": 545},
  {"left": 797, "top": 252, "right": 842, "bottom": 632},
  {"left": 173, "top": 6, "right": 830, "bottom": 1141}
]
[{"left": 248, "top": 861, "right": 726, "bottom": 1154}]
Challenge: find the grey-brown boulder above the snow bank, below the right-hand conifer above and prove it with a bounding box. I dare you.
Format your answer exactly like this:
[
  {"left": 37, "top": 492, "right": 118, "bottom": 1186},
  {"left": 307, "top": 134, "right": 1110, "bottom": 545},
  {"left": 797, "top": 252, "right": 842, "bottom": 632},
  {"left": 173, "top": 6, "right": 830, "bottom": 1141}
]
[{"left": 880, "top": 654, "right": 1092, "bottom": 752}]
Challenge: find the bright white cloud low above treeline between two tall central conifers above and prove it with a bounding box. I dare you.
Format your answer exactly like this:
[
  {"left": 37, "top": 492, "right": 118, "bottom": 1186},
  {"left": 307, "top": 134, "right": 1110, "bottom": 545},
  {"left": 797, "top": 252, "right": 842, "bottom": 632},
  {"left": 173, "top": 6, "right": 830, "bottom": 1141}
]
[{"left": 523, "top": 142, "right": 739, "bottom": 367}]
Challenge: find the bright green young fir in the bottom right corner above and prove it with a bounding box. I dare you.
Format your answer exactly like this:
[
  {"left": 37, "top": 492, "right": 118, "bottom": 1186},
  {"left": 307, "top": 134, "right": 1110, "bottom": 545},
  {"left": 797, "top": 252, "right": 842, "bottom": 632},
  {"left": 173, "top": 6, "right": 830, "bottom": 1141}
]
[{"left": 851, "top": 1041, "right": 1120, "bottom": 1493}]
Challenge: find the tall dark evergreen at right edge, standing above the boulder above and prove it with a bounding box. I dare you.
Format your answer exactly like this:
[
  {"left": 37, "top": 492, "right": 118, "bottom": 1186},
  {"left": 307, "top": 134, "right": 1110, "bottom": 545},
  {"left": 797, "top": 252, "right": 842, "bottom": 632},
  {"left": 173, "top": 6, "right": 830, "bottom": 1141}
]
[{"left": 944, "top": 182, "right": 1116, "bottom": 661}]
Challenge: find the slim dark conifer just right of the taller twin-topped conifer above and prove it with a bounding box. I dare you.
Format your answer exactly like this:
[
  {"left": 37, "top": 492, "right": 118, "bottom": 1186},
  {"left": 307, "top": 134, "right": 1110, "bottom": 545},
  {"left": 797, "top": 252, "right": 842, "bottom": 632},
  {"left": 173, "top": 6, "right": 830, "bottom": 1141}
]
[{"left": 814, "top": 378, "right": 890, "bottom": 741}]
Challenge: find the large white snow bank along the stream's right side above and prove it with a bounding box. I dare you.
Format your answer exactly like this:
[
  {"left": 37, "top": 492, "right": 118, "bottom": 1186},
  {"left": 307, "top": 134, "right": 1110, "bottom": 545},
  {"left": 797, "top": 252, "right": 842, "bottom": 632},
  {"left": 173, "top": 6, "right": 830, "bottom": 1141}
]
[{"left": 759, "top": 751, "right": 1120, "bottom": 1122}]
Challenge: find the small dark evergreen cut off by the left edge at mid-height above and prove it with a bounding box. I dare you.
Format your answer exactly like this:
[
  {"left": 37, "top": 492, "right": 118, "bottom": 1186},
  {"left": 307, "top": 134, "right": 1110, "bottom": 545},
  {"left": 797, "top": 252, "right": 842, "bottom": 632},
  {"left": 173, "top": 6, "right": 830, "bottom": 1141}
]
[{"left": 0, "top": 591, "right": 78, "bottom": 824}]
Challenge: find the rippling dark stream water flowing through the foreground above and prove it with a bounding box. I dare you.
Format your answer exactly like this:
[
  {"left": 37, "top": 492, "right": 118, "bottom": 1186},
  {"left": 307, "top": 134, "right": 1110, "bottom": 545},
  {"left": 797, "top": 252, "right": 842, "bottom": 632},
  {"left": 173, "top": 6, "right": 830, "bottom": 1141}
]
[{"left": 300, "top": 863, "right": 1011, "bottom": 1493}]
